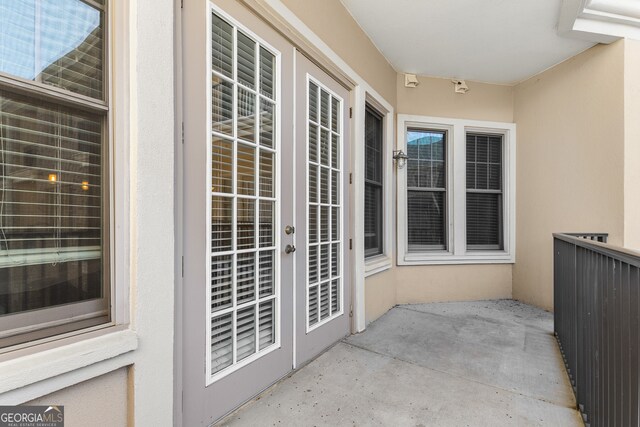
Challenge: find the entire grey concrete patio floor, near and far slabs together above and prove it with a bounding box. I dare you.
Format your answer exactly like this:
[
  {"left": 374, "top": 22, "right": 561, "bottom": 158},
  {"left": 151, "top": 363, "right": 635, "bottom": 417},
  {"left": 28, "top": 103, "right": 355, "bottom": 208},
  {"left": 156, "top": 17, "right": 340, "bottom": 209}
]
[{"left": 222, "top": 300, "right": 583, "bottom": 427}]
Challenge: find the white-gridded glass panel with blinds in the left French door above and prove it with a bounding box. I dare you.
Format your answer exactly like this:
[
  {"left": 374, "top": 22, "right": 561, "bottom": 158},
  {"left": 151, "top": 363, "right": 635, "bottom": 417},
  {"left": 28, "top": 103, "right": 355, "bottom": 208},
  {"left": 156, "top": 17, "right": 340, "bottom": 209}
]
[{"left": 207, "top": 12, "right": 279, "bottom": 383}]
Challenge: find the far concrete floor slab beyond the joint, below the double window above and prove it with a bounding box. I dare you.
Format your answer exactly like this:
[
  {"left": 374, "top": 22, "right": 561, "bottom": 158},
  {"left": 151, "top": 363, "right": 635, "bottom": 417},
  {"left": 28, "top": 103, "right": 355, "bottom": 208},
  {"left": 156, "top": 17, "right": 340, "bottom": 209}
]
[{"left": 347, "top": 300, "right": 575, "bottom": 407}]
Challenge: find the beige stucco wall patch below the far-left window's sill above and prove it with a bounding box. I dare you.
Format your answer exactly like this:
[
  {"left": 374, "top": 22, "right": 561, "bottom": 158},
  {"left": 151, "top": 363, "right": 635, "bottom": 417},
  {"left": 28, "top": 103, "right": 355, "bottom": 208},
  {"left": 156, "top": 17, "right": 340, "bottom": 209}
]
[{"left": 26, "top": 368, "right": 128, "bottom": 427}]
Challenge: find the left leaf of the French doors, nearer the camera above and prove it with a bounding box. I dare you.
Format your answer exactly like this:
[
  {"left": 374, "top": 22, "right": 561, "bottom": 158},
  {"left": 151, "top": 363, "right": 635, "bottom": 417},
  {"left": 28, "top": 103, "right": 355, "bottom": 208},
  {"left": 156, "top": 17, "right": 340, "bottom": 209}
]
[{"left": 182, "top": 1, "right": 294, "bottom": 426}]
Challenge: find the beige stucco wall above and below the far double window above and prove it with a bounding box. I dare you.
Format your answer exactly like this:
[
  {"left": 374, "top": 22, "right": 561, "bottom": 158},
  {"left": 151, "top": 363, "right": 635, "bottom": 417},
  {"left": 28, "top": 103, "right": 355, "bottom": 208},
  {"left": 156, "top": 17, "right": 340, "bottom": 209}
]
[{"left": 365, "top": 73, "right": 513, "bottom": 323}]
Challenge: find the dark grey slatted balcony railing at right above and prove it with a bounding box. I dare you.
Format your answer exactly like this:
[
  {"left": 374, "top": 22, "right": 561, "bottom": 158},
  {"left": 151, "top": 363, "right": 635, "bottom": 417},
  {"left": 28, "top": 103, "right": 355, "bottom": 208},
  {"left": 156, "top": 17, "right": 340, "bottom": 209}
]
[{"left": 553, "top": 233, "right": 640, "bottom": 427}]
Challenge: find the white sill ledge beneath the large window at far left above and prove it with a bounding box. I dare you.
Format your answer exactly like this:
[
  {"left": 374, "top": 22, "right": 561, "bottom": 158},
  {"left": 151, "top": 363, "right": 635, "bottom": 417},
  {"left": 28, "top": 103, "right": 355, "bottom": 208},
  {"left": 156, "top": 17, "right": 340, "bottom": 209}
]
[{"left": 0, "top": 327, "right": 138, "bottom": 404}]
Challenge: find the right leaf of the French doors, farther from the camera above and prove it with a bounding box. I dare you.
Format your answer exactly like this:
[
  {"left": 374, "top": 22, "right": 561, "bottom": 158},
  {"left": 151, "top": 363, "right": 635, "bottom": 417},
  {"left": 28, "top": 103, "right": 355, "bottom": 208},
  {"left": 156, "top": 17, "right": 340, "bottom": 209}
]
[{"left": 295, "top": 52, "right": 351, "bottom": 366}]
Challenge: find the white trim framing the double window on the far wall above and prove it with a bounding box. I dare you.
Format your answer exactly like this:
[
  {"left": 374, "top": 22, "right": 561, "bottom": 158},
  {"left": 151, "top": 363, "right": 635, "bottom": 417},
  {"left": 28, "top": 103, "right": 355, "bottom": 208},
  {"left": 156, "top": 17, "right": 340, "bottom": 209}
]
[{"left": 397, "top": 114, "right": 516, "bottom": 265}]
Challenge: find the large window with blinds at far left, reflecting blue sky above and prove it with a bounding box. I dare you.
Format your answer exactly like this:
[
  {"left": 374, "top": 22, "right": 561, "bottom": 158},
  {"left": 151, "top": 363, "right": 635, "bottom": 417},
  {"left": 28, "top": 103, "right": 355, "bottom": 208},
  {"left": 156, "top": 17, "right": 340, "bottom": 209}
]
[{"left": 0, "top": 0, "right": 109, "bottom": 347}]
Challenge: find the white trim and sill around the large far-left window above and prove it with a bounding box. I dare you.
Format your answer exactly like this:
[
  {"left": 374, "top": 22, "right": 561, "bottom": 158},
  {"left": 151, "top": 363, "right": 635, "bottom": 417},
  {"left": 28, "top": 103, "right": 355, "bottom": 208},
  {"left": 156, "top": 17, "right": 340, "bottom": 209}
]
[{"left": 0, "top": 1, "right": 138, "bottom": 405}]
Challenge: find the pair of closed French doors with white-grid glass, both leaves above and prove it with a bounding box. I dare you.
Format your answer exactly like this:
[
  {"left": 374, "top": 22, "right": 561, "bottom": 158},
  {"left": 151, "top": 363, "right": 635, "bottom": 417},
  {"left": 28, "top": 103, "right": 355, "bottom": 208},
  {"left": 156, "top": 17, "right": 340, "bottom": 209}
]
[{"left": 179, "top": 0, "right": 349, "bottom": 426}]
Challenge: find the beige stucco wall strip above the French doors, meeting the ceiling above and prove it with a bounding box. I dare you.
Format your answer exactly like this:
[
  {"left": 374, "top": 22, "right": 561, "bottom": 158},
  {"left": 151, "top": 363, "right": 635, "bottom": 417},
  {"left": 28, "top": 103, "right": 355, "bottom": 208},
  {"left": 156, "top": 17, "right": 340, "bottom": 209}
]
[{"left": 282, "top": 0, "right": 396, "bottom": 105}]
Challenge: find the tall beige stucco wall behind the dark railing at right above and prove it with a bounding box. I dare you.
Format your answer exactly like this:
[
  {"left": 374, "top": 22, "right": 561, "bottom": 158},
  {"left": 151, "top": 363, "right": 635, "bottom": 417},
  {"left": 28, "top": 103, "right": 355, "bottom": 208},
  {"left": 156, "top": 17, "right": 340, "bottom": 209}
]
[{"left": 513, "top": 42, "right": 637, "bottom": 309}]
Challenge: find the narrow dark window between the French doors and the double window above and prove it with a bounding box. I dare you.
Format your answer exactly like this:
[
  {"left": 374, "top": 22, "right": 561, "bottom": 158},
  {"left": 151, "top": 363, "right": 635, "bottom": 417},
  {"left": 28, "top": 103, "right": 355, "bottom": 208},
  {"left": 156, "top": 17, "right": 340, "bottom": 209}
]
[{"left": 364, "top": 105, "right": 383, "bottom": 257}]
